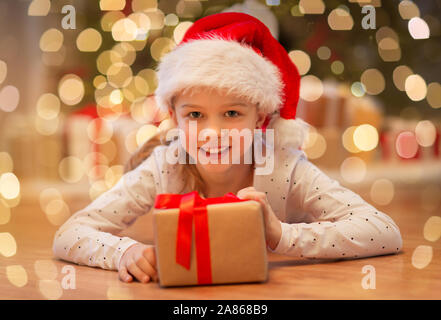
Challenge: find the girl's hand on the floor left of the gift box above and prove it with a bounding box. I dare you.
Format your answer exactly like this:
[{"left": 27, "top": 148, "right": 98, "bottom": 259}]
[{"left": 118, "top": 243, "right": 158, "bottom": 283}]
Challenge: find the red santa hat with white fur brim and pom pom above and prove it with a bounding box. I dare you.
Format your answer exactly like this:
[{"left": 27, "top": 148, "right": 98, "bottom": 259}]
[{"left": 155, "top": 12, "right": 309, "bottom": 148}]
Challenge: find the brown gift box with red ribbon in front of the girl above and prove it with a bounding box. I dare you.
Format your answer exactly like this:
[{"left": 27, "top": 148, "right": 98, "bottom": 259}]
[{"left": 153, "top": 191, "right": 268, "bottom": 287}]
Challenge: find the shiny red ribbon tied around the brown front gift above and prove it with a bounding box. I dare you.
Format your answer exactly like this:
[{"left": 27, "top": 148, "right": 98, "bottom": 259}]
[{"left": 154, "top": 191, "right": 248, "bottom": 284}]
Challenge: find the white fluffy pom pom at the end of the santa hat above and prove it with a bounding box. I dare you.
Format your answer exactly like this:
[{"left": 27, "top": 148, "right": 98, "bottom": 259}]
[{"left": 267, "top": 113, "right": 310, "bottom": 149}]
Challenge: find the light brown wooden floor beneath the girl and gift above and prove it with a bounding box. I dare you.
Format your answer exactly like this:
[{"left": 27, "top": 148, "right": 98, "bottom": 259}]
[{"left": 0, "top": 180, "right": 441, "bottom": 300}]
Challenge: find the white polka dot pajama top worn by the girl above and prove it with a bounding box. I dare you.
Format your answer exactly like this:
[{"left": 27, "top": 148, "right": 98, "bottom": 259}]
[{"left": 53, "top": 142, "right": 402, "bottom": 270}]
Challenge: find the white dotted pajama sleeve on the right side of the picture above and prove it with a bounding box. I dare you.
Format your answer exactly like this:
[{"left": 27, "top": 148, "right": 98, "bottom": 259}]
[{"left": 270, "top": 151, "right": 402, "bottom": 259}]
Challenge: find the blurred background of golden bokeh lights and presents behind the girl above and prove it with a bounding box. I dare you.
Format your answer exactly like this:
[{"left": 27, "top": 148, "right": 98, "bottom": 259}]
[{"left": 0, "top": 0, "right": 441, "bottom": 288}]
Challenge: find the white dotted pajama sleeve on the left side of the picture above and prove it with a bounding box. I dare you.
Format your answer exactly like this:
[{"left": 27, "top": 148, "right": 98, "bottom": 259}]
[{"left": 52, "top": 155, "right": 156, "bottom": 270}]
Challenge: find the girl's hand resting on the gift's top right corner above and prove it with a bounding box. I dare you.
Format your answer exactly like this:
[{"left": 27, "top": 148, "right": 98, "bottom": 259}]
[{"left": 237, "top": 187, "right": 282, "bottom": 250}]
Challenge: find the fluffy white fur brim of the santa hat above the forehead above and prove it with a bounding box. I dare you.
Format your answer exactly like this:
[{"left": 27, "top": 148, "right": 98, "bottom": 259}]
[{"left": 155, "top": 35, "right": 284, "bottom": 113}]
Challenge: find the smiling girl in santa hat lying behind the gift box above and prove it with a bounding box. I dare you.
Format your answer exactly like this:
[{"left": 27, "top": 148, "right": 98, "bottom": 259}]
[{"left": 53, "top": 12, "right": 402, "bottom": 282}]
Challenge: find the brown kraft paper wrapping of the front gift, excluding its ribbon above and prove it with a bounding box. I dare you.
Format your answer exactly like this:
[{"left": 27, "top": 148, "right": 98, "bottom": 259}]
[{"left": 153, "top": 192, "right": 268, "bottom": 287}]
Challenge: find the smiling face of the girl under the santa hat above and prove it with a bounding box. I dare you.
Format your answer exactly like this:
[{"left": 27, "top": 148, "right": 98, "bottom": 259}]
[{"left": 170, "top": 87, "right": 265, "bottom": 173}]
